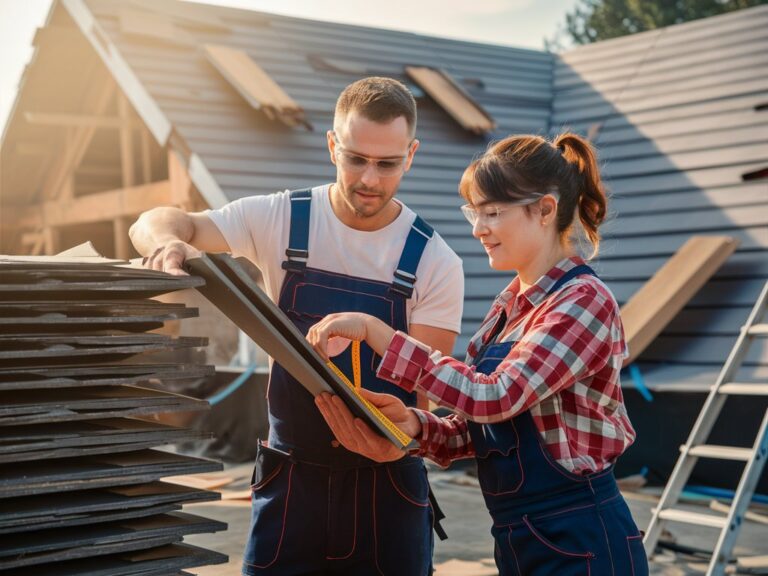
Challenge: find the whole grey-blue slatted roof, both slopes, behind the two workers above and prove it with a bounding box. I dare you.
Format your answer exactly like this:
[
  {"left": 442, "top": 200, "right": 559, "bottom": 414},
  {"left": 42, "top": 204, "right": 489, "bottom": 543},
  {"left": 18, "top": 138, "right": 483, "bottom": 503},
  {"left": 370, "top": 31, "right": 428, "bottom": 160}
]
[{"left": 5, "top": 0, "right": 768, "bottom": 384}]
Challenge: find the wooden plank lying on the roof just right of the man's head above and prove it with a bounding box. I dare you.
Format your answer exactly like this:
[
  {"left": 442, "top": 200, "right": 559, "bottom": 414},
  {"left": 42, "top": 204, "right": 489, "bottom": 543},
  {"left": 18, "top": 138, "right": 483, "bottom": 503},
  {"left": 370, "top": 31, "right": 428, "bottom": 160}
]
[{"left": 405, "top": 66, "right": 496, "bottom": 134}]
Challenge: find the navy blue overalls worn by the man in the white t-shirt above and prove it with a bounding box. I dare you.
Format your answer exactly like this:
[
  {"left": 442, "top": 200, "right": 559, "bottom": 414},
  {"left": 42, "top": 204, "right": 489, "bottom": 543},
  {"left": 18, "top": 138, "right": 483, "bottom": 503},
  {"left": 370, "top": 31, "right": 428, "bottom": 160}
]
[{"left": 243, "top": 190, "right": 438, "bottom": 576}]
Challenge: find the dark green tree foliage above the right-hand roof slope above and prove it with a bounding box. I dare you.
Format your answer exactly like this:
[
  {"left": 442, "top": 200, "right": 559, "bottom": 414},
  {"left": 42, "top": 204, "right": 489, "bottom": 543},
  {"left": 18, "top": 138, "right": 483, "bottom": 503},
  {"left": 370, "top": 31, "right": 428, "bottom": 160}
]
[{"left": 560, "top": 0, "right": 768, "bottom": 46}]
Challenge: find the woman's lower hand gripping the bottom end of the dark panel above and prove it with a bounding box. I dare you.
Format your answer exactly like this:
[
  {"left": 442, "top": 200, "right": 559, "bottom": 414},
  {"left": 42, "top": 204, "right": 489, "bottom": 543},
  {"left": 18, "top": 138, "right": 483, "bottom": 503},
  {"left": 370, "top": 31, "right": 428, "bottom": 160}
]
[{"left": 315, "top": 389, "right": 421, "bottom": 462}]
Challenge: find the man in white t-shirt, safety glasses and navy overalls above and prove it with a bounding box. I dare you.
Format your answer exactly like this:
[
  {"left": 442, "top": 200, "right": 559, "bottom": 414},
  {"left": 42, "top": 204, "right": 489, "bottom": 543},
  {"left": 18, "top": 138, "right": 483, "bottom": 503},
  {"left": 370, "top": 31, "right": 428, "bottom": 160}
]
[{"left": 130, "top": 78, "right": 463, "bottom": 576}]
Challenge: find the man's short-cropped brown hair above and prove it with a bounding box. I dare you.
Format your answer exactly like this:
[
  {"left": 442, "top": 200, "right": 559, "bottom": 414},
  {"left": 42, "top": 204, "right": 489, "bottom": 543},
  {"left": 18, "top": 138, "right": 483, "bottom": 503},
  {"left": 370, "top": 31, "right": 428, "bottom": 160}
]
[{"left": 334, "top": 76, "right": 416, "bottom": 137}]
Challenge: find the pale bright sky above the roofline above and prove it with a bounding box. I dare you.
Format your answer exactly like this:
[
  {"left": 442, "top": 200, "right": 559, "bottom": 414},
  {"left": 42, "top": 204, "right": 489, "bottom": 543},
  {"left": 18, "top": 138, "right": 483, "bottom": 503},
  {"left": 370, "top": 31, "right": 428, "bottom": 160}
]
[{"left": 0, "top": 0, "right": 577, "bottom": 134}]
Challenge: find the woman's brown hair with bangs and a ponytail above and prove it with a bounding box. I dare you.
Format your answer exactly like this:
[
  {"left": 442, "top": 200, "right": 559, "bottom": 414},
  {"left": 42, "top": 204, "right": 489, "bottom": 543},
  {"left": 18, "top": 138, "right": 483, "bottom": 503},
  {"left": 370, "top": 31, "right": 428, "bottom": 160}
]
[{"left": 459, "top": 132, "right": 607, "bottom": 257}]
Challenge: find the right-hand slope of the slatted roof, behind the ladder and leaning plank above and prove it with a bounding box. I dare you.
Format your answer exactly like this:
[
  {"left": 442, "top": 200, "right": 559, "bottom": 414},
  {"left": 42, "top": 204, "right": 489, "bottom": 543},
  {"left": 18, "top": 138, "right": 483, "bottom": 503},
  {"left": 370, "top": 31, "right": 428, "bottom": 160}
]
[{"left": 551, "top": 6, "right": 768, "bottom": 384}]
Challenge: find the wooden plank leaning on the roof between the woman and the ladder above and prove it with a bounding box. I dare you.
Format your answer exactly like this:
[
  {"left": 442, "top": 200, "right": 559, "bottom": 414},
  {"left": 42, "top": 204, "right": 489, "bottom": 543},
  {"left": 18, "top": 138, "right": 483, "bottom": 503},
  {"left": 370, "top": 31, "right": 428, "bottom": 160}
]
[{"left": 621, "top": 236, "right": 737, "bottom": 365}]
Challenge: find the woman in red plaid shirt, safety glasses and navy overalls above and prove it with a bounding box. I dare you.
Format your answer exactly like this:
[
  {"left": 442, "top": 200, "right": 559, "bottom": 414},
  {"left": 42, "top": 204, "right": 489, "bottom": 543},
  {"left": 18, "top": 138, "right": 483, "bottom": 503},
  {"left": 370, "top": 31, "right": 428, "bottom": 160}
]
[{"left": 308, "top": 133, "right": 648, "bottom": 576}]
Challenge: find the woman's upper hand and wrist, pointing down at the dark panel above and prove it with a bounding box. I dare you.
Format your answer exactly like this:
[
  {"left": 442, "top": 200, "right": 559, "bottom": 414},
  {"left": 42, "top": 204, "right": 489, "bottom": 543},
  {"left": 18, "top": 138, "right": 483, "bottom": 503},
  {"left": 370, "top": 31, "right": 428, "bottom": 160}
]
[{"left": 307, "top": 312, "right": 395, "bottom": 361}]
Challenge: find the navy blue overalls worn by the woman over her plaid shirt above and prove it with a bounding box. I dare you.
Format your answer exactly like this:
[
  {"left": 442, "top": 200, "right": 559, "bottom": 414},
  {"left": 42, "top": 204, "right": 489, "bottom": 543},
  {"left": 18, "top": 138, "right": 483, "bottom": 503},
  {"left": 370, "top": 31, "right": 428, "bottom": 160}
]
[{"left": 468, "top": 265, "right": 648, "bottom": 576}]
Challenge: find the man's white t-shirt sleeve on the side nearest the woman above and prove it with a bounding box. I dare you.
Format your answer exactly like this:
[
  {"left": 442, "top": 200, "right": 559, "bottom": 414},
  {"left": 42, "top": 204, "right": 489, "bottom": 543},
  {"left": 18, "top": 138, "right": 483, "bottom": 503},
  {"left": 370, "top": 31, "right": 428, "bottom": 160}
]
[{"left": 410, "top": 236, "right": 464, "bottom": 333}]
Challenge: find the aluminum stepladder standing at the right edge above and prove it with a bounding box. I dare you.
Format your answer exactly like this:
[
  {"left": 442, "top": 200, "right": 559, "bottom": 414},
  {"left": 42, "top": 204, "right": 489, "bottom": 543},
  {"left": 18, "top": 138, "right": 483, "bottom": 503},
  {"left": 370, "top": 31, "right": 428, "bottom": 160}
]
[{"left": 643, "top": 282, "right": 768, "bottom": 576}]
